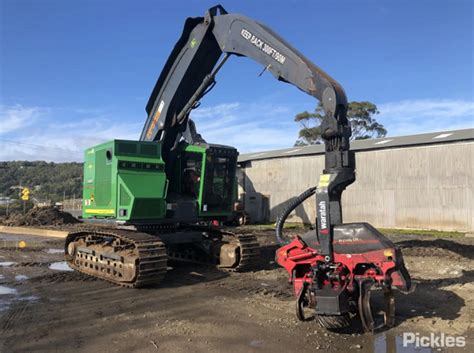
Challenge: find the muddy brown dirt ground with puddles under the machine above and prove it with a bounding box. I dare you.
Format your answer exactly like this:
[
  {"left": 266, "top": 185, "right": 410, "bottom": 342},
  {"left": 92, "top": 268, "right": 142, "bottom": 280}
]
[{"left": 0, "top": 227, "right": 474, "bottom": 353}]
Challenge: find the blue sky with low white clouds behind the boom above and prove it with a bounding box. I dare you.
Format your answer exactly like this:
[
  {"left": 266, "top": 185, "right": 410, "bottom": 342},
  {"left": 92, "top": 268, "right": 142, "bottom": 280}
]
[{"left": 0, "top": 0, "right": 474, "bottom": 162}]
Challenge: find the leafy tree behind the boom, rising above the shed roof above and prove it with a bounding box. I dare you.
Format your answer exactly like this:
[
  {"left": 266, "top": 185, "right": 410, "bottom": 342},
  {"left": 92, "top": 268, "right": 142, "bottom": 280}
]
[{"left": 295, "top": 102, "right": 387, "bottom": 146}]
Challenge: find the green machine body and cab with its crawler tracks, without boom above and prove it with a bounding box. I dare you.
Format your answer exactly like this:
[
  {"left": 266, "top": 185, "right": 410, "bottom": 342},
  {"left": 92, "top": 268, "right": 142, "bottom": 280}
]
[{"left": 65, "top": 134, "right": 260, "bottom": 287}]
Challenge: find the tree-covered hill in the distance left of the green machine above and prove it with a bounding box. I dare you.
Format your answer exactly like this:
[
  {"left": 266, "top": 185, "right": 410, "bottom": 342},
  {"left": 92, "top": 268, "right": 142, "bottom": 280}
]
[{"left": 0, "top": 161, "right": 82, "bottom": 202}]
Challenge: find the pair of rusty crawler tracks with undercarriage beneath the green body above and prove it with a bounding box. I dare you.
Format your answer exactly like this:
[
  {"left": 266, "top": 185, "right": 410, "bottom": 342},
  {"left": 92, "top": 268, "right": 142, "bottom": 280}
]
[{"left": 65, "top": 227, "right": 260, "bottom": 288}]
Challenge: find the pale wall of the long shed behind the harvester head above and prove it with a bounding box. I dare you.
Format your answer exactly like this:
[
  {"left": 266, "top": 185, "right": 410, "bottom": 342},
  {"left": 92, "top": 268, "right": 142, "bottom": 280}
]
[{"left": 243, "top": 142, "right": 474, "bottom": 231}]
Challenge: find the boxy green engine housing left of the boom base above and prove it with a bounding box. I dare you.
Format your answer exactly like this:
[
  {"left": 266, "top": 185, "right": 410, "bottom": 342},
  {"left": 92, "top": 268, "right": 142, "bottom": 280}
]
[{"left": 82, "top": 140, "right": 168, "bottom": 221}]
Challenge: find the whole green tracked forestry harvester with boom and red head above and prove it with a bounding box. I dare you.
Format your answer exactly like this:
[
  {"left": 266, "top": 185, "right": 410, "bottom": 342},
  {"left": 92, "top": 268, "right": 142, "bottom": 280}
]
[{"left": 65, "top": 6, "right": 410, "bottom": 330}]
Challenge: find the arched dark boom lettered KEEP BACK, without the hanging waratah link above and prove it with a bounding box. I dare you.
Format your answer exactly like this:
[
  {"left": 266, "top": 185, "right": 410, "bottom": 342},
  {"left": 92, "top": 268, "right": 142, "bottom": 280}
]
[{"left": 140, "top": 6, "right": 350, "bottom": 153}]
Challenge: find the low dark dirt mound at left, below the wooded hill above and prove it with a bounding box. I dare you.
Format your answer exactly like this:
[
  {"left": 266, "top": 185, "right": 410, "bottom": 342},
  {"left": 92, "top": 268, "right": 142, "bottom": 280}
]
[{"left": 1, "top": 207, "right": 80, "bottom": 226}]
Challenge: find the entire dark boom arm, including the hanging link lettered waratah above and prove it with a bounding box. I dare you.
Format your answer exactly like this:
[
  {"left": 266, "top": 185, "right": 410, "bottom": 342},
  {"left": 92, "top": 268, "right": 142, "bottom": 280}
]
[{"left": 140, "top": 5, "right": 355, "bottom": 261}]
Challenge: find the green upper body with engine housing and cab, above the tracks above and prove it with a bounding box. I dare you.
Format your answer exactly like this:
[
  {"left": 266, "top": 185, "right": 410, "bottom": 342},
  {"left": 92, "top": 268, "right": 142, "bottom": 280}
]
[{"left": 82, "top": 140, "right": 238, "bottom": 224}]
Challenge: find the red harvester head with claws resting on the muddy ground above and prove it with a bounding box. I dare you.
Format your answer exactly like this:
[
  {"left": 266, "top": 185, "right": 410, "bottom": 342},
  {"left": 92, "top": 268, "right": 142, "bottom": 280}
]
[{"left": 276, "top": 205, "right": 414, "bottom": 332}]
